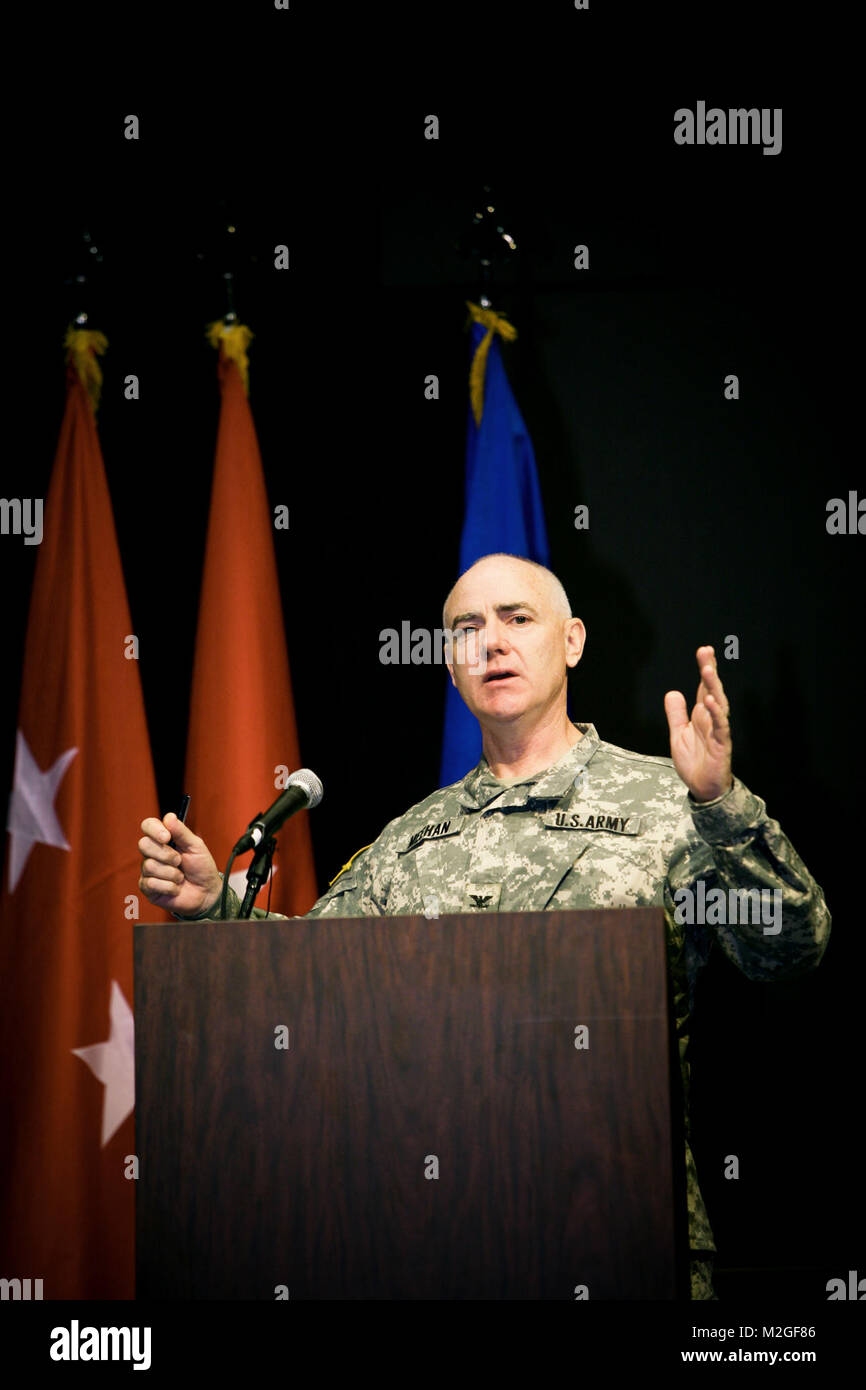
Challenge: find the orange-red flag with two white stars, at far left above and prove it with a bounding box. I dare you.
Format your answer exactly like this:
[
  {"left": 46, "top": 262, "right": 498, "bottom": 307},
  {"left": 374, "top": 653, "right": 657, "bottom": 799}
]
[{"left": 0, "top": 329, "right": 170, "bottom": 1298}]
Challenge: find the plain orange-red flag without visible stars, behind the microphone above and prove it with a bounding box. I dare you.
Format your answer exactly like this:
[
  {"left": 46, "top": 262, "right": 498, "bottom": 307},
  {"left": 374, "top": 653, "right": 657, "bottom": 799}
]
[{"left": 185, "top": 322, "right": 318, "bottom": 916}]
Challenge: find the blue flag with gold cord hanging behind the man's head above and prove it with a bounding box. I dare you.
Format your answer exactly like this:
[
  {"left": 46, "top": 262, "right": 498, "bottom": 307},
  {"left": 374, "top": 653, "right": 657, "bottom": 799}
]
[{"left": 439, "top": 322, "right": 549, "bottom": 787}]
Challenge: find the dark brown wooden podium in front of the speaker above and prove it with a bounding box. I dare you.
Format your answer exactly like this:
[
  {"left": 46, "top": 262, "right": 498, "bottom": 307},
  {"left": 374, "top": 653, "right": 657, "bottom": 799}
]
[{"left": 135, "top": 908, "right": 688, "bottom": 1301}]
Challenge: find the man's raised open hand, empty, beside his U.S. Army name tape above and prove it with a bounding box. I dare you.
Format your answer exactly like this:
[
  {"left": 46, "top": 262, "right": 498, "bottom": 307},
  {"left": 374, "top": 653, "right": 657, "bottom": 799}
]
[{"left": 664, "top": 646, "right": 734, "bottom": 801}]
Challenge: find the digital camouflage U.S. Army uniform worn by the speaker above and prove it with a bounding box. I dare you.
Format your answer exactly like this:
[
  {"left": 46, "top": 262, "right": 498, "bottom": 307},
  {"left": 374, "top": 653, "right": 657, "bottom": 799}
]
[{"left": 187, "top": 724, "right": 830, "bottom": 1298}]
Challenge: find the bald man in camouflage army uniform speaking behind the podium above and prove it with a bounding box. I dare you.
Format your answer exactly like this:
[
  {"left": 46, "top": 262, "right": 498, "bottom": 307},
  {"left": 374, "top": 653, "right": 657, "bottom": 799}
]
[{"left": 139, "top": 555, "right": 830, "bottom": 1300}]
